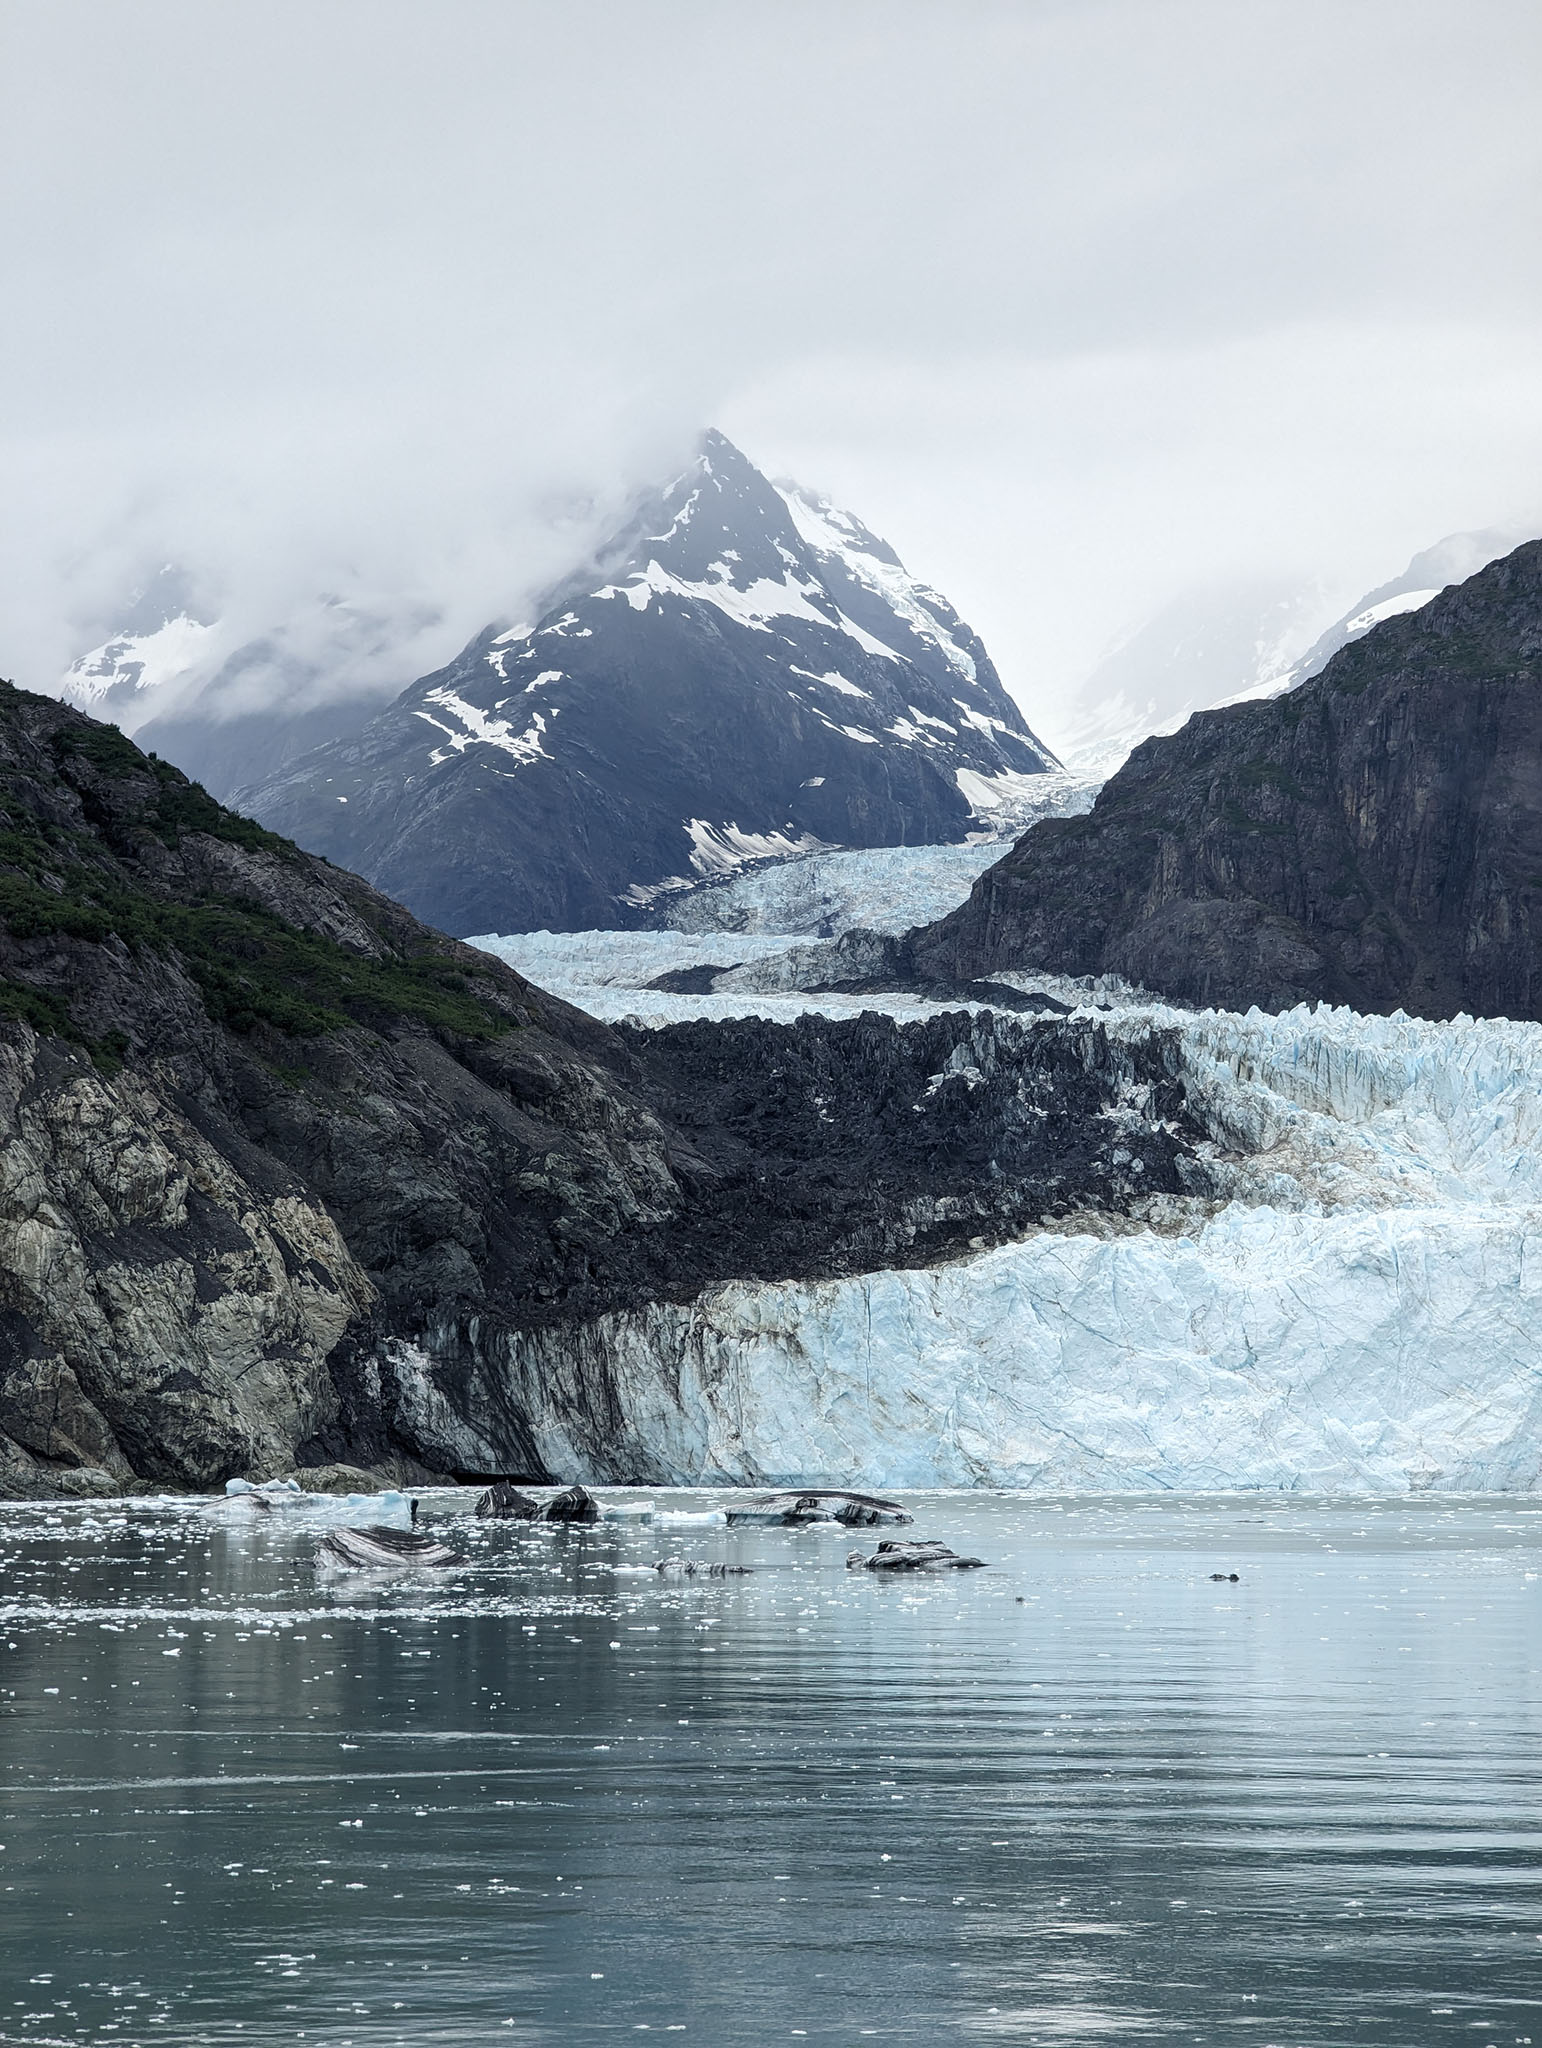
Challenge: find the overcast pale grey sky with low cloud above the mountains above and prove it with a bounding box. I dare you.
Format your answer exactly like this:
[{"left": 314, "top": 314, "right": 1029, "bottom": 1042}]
[{"left": 0, "top": 0, "right": 1542, "bottom": 733}]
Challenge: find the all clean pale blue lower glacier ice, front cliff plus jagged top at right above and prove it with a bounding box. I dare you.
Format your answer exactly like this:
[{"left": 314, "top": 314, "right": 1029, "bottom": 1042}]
[{"left": 479, "top": 997, "right": 1542, "bottom": 1493}]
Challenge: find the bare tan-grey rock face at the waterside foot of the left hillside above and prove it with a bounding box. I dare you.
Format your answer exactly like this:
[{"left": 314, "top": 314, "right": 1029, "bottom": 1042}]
[{"left": 0, "top": 1032, "right": 375, "bottom": 1491}]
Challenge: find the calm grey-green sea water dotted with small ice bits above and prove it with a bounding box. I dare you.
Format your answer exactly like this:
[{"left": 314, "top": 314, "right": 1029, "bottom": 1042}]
[{"left": 0, "top": 1495, "right": 1542, "bottom": 2048}]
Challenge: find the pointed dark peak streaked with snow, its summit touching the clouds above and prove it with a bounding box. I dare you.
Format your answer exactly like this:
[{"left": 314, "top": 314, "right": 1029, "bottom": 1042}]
[{"left": 240, "top": 434, "right": 1055, "bottom": 934}]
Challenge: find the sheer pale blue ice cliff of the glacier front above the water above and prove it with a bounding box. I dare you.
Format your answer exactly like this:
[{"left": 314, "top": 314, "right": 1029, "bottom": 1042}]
[{"left": 507, "top": 1208, "right": 1542, "bottom": 1493}]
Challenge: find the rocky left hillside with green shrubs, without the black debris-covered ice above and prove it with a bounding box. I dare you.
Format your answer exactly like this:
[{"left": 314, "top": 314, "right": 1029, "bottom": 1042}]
[{"left": 0, "top": 686, "right": 678, "bottom": 1495}]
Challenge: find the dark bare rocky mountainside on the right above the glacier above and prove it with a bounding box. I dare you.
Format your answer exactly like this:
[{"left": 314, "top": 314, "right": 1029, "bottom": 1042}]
[{"left": 909, "top": 541, "right": 1542, "bottom": 1018}]
